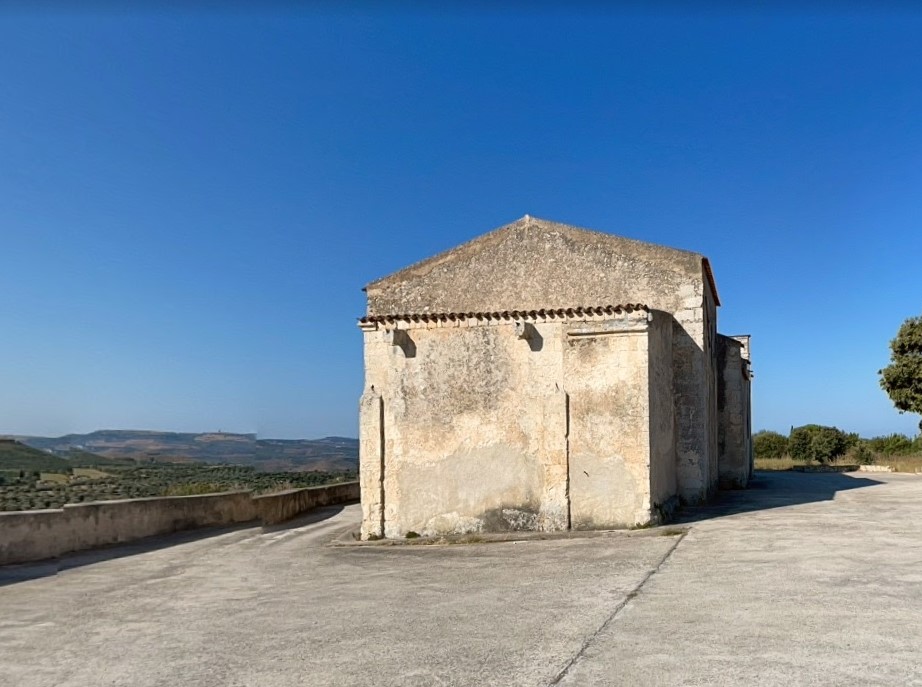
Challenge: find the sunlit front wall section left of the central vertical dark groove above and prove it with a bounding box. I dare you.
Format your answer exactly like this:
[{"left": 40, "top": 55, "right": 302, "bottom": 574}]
[{"left": 361, "top": 322, "right": 567, "bottom": 538}]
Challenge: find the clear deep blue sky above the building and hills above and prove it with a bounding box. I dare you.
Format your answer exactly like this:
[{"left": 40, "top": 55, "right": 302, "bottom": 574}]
[{"left": 0, "top": 3, "right": 922, "bottom": 438}]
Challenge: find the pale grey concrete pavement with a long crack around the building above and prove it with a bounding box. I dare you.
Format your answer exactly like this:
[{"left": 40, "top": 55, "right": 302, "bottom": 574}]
[{"left": 0, "top": 473, "right": 922, "bottom": 687}]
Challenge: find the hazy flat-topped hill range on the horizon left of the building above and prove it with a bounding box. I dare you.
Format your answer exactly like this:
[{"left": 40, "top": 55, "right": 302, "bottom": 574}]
[{"left": 15, "top": 430, "right": 359, "bottom": 471}]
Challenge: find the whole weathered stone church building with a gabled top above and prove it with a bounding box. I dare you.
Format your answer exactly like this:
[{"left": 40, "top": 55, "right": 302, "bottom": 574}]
[{"left": 359, "top": 216, "right": 752, "bottom": 539}]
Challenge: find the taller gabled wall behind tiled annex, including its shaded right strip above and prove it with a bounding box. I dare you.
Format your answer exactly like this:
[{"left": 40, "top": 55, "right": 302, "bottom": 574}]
[{"left": 366, "top": 217, "right": 717, "bottom": 503}]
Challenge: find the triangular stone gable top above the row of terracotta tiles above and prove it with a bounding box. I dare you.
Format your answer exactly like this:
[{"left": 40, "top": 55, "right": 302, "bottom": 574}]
[{"left": 365, "top": 215, "right": 717, "bottom": 315}]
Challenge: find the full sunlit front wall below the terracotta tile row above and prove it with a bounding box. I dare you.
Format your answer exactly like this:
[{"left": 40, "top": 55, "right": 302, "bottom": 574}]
[{"left": 360, "top": 311, "right": 674, "bottom": 538}]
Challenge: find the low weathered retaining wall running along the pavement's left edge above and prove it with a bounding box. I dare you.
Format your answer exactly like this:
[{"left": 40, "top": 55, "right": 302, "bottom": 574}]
[{"left": 0, "top": 482, "right": 359, "bottom": 565}]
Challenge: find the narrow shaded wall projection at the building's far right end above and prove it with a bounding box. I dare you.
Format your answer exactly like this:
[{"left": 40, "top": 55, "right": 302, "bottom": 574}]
[{"left": 717, "top": 335, "right": 752, "bottom": 489}]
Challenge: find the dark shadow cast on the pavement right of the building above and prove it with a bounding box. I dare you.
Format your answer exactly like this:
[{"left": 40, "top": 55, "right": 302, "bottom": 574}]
[{"left": 676, "top": 471, "right": 883, "bottom": 523}]
